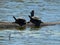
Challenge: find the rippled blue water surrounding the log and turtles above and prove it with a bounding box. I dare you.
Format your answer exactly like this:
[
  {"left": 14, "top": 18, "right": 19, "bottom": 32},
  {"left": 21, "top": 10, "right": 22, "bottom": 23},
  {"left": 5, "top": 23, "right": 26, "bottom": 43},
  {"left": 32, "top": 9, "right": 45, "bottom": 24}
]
[{"left": 0, "top": 0, "right": 60, "bottom": 45}]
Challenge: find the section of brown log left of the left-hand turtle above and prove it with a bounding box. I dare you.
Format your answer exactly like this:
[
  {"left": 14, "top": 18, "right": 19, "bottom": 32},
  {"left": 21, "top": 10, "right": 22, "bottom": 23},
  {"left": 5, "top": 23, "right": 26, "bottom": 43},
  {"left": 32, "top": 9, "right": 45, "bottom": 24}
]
[{"left": 0, "top": 22, "right": 19, "bottom": 28}]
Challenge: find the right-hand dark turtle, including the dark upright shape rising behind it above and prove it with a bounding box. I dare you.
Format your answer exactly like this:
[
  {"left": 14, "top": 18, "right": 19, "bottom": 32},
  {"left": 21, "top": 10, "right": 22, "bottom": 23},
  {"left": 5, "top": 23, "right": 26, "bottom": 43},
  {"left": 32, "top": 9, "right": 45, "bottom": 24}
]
[{"left": 29, "top": 10, "right": 43, "bottom": 26}]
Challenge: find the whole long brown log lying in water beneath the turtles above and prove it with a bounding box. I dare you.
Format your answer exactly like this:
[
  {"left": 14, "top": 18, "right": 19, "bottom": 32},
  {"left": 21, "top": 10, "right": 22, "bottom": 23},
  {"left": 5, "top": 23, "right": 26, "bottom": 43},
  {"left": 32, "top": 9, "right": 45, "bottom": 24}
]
[{"left": 0, "top": 22, "right": 60, "bottom": 28}]
